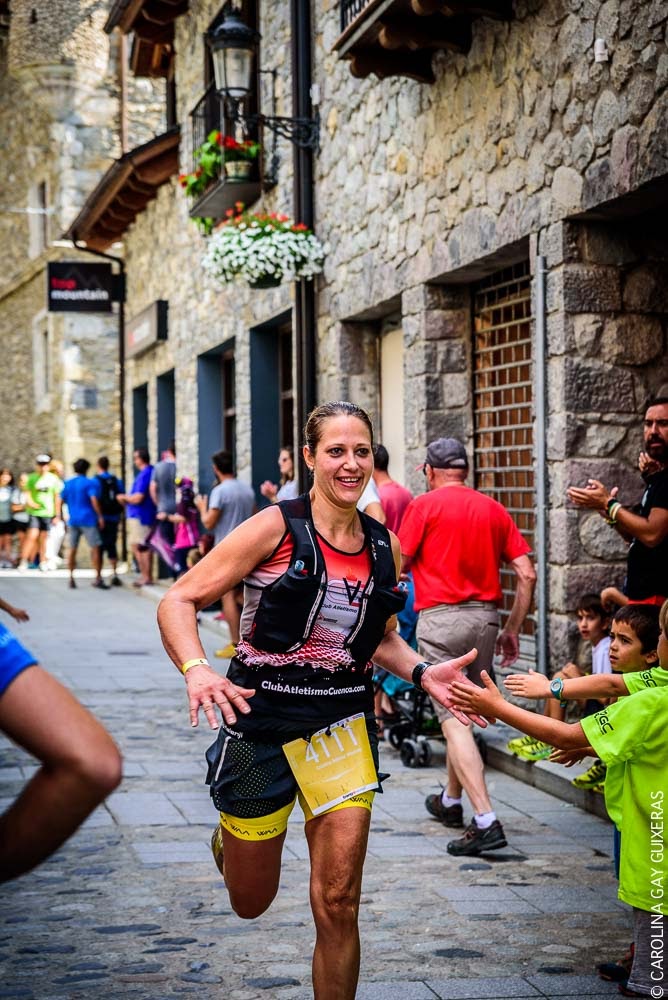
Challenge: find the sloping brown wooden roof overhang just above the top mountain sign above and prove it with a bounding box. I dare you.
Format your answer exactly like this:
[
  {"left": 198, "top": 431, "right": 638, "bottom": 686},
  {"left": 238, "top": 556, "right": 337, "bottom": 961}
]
[{"left": 64, "top": 126, "right": 180, "bottom": 250}]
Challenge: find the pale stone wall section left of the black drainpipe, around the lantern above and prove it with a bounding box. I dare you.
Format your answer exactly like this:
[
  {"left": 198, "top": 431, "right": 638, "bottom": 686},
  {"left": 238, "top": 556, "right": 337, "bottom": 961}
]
[{"left": 118, "top": 2, "right": 293, "bottom": 490}]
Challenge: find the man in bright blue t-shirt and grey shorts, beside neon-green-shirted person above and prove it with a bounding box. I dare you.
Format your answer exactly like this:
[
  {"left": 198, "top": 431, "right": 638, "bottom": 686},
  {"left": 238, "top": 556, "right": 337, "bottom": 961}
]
[{"left": 58, "top": 458, "right": 109, "bottom": 590}]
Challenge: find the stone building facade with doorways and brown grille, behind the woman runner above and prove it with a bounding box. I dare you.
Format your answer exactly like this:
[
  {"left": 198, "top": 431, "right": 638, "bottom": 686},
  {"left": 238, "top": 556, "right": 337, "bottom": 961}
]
[{"left": 58, "top": 0, "right": 668, "bottom": 664}]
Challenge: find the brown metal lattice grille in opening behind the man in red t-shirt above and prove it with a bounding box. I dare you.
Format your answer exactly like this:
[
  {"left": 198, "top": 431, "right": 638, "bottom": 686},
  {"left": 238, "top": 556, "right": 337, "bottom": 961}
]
[{"left": 473, "top": 261, "right": 535, "bottom": 658}]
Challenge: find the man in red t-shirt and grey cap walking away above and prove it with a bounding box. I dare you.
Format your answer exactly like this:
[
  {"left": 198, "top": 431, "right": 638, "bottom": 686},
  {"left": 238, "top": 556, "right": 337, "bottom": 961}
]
[{"left": 399, "top": 438, "right": 536, "bottom": 855}]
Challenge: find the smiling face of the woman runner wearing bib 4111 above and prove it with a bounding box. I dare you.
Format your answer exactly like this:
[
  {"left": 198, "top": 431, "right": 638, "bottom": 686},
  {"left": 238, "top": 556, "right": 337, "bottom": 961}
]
[{"left": 304, "top": 414, "right": 373, "bottom": 506}]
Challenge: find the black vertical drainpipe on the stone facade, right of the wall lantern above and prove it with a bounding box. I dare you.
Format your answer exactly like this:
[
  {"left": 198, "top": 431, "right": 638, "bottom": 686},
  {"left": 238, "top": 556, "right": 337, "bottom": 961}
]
[{"left": 290, "top": 0, "right": 316, "bottom": 489}]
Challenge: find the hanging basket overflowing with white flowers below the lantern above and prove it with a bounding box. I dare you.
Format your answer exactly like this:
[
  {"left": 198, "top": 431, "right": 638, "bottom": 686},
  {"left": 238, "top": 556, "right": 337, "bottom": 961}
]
[{"left": 202, "top": 202, "right": 325, "bottom": 288}]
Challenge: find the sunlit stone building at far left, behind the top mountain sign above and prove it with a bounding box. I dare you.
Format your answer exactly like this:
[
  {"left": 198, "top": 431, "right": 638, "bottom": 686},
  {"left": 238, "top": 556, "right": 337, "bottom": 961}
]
[{"left": 0, "top": 0, "right": 164, "bottom": 474}]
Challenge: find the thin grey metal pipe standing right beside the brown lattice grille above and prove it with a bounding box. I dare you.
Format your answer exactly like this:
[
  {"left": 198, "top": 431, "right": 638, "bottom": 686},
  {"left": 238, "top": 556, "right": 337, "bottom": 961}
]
[{"left": 534, "top": 256, "right": 548, "bottom": 674}]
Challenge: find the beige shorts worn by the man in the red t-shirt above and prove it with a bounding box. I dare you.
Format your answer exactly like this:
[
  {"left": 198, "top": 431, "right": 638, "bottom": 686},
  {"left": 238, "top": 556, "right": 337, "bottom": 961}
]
[{"left": 417, "top": 601, "right": 499, "bottom": 722}]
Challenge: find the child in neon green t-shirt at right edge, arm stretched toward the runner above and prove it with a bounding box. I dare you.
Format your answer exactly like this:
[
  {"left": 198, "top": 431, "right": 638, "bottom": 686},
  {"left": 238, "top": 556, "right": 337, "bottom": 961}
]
[{"left": 452, "top": 601, "right": 668, "bottom": 997}]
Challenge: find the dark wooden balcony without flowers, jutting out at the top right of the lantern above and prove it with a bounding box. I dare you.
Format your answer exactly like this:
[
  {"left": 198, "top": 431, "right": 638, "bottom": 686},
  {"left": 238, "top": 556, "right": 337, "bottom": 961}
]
[{"left": 334, "top": 0, "right": 512, "bottom": 83}]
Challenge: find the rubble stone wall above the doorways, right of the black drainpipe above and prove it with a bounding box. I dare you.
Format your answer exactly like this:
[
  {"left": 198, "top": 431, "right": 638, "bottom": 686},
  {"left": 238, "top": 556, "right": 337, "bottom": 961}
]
[{"left": 315, "top": 0, "right": 668, "bottom": 320}]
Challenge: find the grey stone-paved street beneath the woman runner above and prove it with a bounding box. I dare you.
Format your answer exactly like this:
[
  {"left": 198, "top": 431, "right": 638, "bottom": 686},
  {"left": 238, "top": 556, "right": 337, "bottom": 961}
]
[{"left": 0, "top": 571, "right": 631, "bottom": 1000}]
